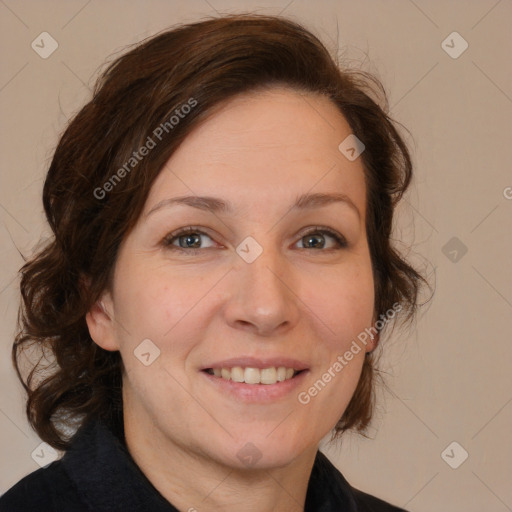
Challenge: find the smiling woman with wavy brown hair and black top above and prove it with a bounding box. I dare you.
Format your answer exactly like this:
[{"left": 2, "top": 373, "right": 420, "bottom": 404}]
[{"left": 0, "top": 15, "right": 426, "bottom": 512}]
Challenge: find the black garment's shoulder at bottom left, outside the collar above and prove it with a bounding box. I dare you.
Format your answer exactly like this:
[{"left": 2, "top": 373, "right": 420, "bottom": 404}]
[{"left": 0, "top": 460, "right": 86, "bottom": 512}]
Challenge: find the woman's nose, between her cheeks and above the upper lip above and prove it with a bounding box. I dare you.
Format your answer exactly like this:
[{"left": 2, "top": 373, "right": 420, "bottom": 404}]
[{"left": 224, "top": 243, "right": 300, "bottom": 337}]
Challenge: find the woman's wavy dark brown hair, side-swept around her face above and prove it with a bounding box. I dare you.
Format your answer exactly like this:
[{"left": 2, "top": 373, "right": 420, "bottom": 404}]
[{"left": 12, "top": 15, "right": 426, "bottom": 450}]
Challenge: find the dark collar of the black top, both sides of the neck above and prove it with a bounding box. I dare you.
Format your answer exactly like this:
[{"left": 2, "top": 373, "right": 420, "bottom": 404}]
[{"left": 62, "top": 421, "right": 358, "bottom": 512}]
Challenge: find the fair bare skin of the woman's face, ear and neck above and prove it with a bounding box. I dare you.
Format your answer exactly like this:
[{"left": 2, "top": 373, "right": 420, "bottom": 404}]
[{"left": 87, "top": 88, "right": 374, "bottom": 512}]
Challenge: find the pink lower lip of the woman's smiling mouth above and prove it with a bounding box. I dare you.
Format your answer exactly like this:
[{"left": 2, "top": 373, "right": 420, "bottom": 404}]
[{"left": 200, "top": 370, "right": 309, "bottom": 403}]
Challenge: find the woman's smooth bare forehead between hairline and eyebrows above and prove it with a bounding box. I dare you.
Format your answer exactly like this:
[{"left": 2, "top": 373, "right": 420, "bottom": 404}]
[{"left": 145, "top": 88, "right": 365, "bottom": 219}]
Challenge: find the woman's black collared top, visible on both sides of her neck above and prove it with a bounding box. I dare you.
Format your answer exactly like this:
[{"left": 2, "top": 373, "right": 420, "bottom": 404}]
[{"left": 0, "top": 420, "right": 405, "bottom": 512}]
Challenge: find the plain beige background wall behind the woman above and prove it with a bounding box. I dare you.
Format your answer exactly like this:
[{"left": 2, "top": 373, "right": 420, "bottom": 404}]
[{"left": 0, "top": 0, "right": 512, "bottom": 512}]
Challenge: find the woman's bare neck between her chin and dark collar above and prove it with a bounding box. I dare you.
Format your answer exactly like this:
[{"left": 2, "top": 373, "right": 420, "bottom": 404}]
[{"left": 124, "top": 404, "right": 318, "bottom": 512}]
